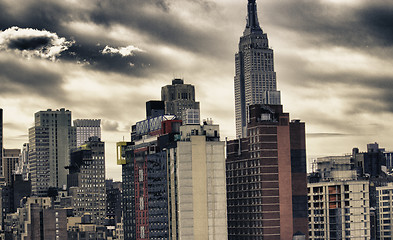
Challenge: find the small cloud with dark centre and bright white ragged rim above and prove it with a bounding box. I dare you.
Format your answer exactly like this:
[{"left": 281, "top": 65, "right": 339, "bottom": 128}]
[{"left": 0, "top": 26, "right": 74, "bottom": 61}]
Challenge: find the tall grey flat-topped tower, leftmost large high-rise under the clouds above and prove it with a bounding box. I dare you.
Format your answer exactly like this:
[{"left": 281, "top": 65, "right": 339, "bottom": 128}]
[{"left": 29, "top": 108, "right": 76, "bottom": 196}]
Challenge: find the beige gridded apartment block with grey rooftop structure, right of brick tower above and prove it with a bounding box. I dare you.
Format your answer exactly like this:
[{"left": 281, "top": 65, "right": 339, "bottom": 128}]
[{"left": 307, "top": 156, "right": 371, "bottom": 240}]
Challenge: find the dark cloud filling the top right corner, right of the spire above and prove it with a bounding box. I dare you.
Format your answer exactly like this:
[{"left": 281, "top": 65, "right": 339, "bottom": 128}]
[{"left": 269, "top": 0, "right": 393, "bottom": 51}]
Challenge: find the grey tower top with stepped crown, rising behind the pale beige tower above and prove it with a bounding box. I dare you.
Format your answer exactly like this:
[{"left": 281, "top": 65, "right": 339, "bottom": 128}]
[{"left": 161, "top": 79, "right": 200, "bottom": 124}]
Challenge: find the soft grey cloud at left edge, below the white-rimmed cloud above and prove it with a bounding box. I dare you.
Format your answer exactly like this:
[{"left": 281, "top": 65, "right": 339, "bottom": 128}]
[{"left": 0, "top": 56, "right": 64, "bottom": 98}]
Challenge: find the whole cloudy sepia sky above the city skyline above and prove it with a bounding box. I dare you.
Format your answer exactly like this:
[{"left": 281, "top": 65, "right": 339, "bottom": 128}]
[{"left": 0, "top": 0, "right": 393, "bottom": 180}]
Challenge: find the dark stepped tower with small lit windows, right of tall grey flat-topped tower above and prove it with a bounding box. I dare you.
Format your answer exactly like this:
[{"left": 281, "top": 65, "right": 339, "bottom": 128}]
[{"left": 67, "top": 137, "right": 106, "bottom": 225}]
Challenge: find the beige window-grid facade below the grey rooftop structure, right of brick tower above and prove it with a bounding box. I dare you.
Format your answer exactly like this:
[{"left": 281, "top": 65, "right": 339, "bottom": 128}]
[{"left": 308, "top": 180, "right": 371, "bottom": 240}]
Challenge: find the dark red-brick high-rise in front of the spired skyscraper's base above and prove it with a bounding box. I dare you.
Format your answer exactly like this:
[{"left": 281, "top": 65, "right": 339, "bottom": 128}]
[{"left": 226, "top": 104, "right": 308, "bottom": 240}]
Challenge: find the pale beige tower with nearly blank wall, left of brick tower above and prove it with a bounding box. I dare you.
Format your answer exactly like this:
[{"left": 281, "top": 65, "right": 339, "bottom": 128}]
[{"left": 168, "top": 122, "right": 228, "bottom": 240}]
